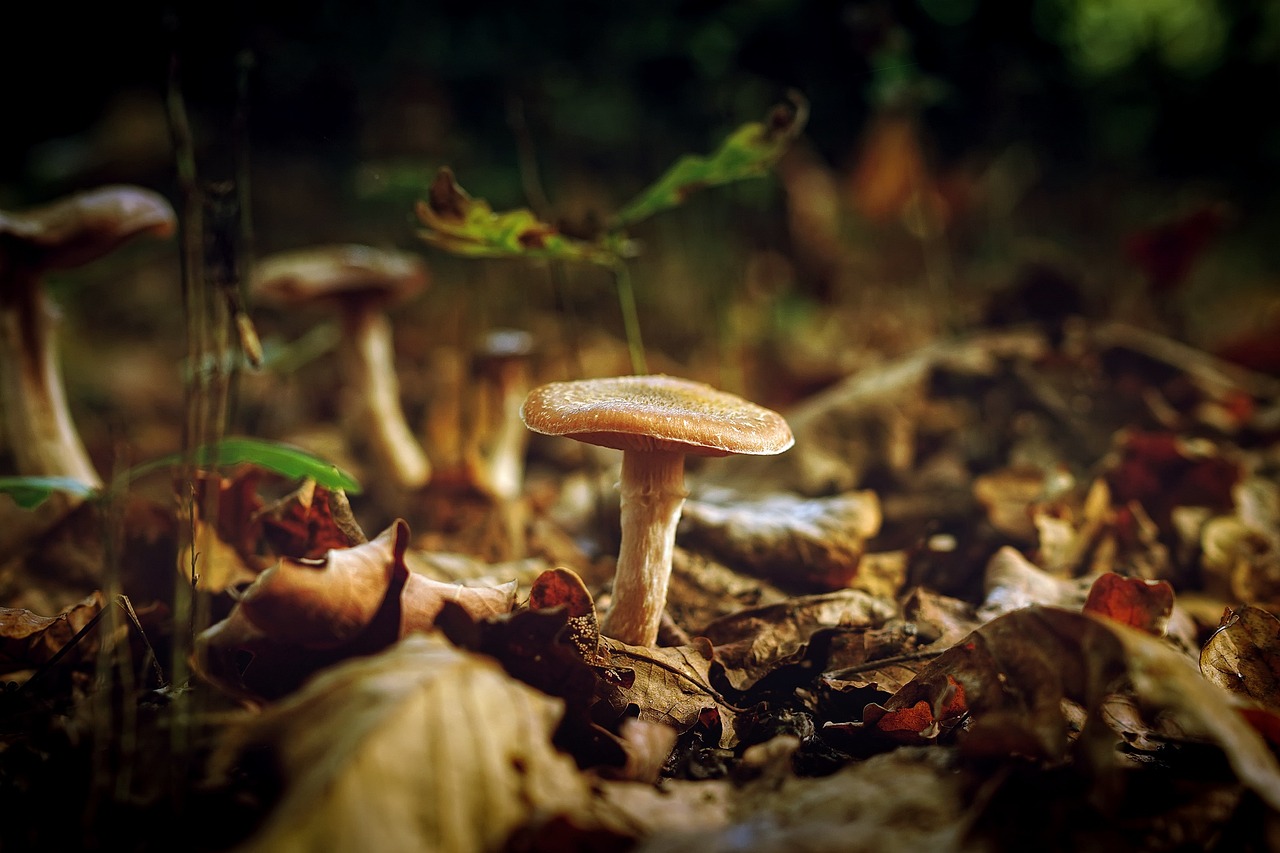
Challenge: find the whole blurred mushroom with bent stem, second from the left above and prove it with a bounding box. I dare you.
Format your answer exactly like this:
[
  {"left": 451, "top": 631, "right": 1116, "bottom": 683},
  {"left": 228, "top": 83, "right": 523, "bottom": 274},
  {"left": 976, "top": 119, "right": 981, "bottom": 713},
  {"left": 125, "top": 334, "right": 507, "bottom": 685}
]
[{"left": 252, "top": 243, "right": 431, "bottom": 489}]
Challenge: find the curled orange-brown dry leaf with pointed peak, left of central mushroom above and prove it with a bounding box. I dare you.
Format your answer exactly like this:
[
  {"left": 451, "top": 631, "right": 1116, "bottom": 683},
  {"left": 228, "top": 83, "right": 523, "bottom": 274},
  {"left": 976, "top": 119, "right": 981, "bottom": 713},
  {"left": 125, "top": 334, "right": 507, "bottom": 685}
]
[{"left": 193, "top": 520, "right": 515, "bottom": 698}]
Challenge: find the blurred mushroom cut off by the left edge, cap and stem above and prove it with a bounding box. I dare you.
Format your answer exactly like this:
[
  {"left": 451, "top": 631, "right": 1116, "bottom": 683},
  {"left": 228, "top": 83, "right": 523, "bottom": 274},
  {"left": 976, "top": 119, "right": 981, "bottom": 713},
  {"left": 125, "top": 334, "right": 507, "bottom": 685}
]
[{"left": 0, "top": 184, "right": 177, "bottom": 488}]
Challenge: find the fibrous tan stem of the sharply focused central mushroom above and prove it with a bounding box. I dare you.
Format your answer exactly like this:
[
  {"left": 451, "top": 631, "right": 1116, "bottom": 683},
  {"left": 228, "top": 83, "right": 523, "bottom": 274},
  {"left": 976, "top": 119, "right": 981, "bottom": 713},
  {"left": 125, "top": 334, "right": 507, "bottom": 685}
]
[{"left": 600, "top": 451, "right": 687, "bottom": 646}]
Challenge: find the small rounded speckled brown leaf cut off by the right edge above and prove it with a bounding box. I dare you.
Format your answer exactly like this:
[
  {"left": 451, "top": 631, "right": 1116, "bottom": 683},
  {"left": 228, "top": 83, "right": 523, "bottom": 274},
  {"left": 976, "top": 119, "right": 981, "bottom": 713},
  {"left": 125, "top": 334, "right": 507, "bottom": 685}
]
[{"left": 1199, "top": 606, "right": 1280, "bottom": 715}]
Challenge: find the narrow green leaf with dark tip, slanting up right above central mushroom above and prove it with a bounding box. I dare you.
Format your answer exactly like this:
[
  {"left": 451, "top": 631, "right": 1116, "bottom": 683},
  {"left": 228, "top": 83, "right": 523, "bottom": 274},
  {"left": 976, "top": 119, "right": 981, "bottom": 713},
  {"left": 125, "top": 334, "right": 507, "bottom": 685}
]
[{"left": 611, "top": 92, "right": 809, "bottom": 231}]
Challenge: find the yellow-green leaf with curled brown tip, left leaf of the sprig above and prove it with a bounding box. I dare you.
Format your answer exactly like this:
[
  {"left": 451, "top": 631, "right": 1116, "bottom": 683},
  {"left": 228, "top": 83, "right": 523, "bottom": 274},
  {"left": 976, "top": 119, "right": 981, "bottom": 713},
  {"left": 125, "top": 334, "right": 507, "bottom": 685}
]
[{"left": 415, "top": 167, "right": 620, "bottom": 266}]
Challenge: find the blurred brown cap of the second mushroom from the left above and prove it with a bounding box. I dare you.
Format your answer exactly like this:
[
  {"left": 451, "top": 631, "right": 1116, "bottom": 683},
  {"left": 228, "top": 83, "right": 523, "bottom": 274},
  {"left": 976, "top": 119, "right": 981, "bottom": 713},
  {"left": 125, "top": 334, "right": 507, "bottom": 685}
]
[{"left": 252, "top": 243, "right": 428, "bottom": 305}]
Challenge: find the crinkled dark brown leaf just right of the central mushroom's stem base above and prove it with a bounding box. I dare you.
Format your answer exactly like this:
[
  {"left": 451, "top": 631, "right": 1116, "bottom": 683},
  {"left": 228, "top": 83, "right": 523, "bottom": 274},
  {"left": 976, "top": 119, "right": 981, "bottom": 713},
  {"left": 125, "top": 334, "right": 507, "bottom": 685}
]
[{"left": 703, "top": 589, "right": 897, "bottom": 690}]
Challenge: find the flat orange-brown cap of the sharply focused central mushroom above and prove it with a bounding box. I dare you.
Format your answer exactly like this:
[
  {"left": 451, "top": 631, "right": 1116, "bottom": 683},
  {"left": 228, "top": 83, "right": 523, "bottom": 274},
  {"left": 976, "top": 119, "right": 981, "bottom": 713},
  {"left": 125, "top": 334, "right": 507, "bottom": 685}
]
[{"left": 521, "top": 375, "right": 795, "bottom": 456}]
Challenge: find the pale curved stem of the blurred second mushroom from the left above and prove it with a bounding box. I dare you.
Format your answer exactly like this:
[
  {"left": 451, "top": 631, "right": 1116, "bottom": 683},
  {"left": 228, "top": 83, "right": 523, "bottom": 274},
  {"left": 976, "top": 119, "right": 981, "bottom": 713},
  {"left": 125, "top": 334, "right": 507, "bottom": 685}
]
[{"left": 343, "top": 309, "right": 431, "bottom": 489}]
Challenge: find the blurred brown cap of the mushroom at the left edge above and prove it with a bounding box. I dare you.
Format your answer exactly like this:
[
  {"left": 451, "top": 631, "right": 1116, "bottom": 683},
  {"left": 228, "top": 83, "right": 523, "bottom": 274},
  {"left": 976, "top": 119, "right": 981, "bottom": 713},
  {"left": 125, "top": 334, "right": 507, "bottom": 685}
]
[{"left": 0, "top": 184, "right": 178, "bottom": 269}]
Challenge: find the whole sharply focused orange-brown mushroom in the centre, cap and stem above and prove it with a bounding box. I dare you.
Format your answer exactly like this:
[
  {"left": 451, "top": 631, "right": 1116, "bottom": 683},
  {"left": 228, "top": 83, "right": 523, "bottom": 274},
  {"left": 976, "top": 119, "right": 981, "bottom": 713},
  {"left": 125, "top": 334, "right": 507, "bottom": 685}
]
[{"left": 521, "top": 375, "right": 795, "bottom": 646}]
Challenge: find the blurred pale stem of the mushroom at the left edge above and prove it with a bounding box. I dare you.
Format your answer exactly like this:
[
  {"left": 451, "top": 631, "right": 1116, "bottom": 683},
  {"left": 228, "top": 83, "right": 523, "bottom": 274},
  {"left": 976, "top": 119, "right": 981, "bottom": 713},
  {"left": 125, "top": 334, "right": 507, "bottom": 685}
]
[{"left": 0, "top": 283, "right": 102, "bottom": 487}]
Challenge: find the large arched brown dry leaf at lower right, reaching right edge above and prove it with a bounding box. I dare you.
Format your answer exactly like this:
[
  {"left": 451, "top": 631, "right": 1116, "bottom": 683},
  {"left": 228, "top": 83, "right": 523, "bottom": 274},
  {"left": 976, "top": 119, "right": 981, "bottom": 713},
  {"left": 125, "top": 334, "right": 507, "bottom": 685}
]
[{"left": 849, "top": 606, "right": 1280, "bottom": 808}]
